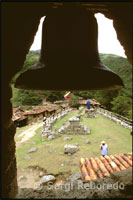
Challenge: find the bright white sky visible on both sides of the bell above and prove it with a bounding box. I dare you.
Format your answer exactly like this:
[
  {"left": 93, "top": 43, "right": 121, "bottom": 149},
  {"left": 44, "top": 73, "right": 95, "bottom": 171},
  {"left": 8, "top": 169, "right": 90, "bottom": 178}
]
[{"left": 30, "top": 13, "right": 126, "bottom": 58}]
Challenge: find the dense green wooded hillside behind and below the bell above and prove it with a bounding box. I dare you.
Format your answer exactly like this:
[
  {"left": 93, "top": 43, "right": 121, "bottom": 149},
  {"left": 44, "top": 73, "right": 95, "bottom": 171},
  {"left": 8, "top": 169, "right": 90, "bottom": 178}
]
[{"left": 11, "top": 52, "right": 132, "bottom": 118}]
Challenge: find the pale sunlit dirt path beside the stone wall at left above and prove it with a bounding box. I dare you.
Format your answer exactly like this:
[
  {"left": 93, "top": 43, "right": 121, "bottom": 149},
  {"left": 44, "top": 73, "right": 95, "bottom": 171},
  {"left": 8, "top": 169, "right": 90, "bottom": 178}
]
[{"left": 16, "top": 122, "right": 43, "bottom": 146}]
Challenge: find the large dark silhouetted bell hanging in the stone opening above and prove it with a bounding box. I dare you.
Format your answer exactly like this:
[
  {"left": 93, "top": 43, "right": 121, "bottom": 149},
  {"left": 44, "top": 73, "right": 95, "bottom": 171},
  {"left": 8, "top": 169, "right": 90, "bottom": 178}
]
[{"left": 15, "top": 7, "right": 123, "bottom": 91}]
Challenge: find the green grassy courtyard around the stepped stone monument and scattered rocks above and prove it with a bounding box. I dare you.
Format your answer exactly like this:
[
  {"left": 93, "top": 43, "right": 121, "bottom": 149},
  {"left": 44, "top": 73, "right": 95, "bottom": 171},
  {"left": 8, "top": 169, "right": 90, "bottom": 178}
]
[{"left": 15, "top": 110, "right": 132, "bottom": 174}]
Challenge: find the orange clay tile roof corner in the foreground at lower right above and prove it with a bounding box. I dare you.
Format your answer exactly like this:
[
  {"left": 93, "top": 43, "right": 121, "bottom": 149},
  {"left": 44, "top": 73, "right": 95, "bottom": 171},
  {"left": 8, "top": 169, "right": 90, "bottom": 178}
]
[{"left": 79, "top": 153, "right": 132, "bottom": 181}]
